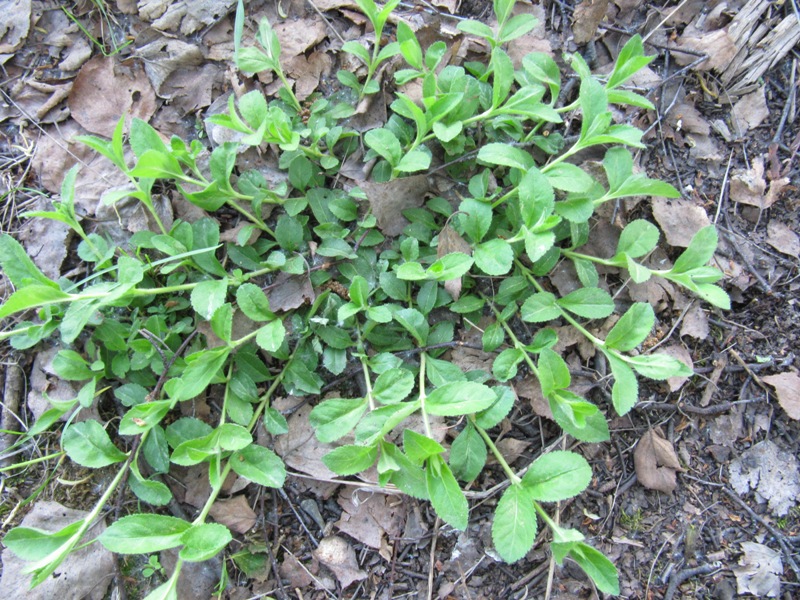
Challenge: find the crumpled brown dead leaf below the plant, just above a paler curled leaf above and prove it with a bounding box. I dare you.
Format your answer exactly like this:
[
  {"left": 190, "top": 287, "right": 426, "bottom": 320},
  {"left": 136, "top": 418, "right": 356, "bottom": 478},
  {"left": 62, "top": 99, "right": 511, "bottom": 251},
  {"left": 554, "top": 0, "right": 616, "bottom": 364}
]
[{"left": 336, "top": 486, "right": 406, "bottom": 550}]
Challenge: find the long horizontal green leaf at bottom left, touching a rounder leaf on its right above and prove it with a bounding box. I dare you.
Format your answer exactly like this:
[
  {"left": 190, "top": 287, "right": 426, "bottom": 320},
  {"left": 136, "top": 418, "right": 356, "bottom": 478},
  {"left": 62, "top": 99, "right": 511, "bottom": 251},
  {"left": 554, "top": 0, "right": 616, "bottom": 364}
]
[{"left": 97, "top": 514, "right": 192, "bottom": 554}]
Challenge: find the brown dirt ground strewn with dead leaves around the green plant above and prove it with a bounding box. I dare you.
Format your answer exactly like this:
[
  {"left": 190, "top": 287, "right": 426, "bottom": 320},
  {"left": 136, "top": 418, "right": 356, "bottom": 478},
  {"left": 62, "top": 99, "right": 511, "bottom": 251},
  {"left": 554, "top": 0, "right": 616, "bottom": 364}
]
[{"left": 0, "top": 0, "right": 800, "bottom": 600}]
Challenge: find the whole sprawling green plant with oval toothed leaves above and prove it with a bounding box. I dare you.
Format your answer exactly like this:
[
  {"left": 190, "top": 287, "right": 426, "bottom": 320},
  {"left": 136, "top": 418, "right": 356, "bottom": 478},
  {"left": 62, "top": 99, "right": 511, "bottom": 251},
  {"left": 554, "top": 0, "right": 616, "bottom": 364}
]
[{"left": 0, "top": 0, "right": 729, "bottom": 598}]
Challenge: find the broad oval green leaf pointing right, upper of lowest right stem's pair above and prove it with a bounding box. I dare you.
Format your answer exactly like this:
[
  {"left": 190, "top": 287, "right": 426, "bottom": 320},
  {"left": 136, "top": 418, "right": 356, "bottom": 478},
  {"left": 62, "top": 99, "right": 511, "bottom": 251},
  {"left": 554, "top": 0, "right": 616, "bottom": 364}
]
[{"left": 522, "top": 450, "right": 592, "bottom": 502}]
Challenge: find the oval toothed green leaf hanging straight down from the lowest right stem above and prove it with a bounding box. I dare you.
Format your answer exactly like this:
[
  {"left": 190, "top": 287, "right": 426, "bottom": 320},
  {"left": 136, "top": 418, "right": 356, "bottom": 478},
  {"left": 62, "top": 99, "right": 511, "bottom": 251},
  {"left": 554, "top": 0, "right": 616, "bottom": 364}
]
[{"left": 492, "top": 484, "right": 538, "bottom": 563}]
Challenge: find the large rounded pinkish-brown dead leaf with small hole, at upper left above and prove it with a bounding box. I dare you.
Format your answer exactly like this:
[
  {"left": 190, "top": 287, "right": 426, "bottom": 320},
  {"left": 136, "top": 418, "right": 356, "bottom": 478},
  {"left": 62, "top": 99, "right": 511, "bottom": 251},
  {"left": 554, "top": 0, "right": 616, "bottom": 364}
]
[{"left": 67, "top": 56, "right": 156, "bottom": 138}]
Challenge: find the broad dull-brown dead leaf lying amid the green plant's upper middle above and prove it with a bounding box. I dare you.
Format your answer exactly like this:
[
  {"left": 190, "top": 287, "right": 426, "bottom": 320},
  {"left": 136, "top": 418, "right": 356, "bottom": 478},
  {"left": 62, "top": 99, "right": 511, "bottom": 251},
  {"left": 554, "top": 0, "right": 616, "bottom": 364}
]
[{"left": 357, "top": 175, "right": 430, "bottom": 237}]
